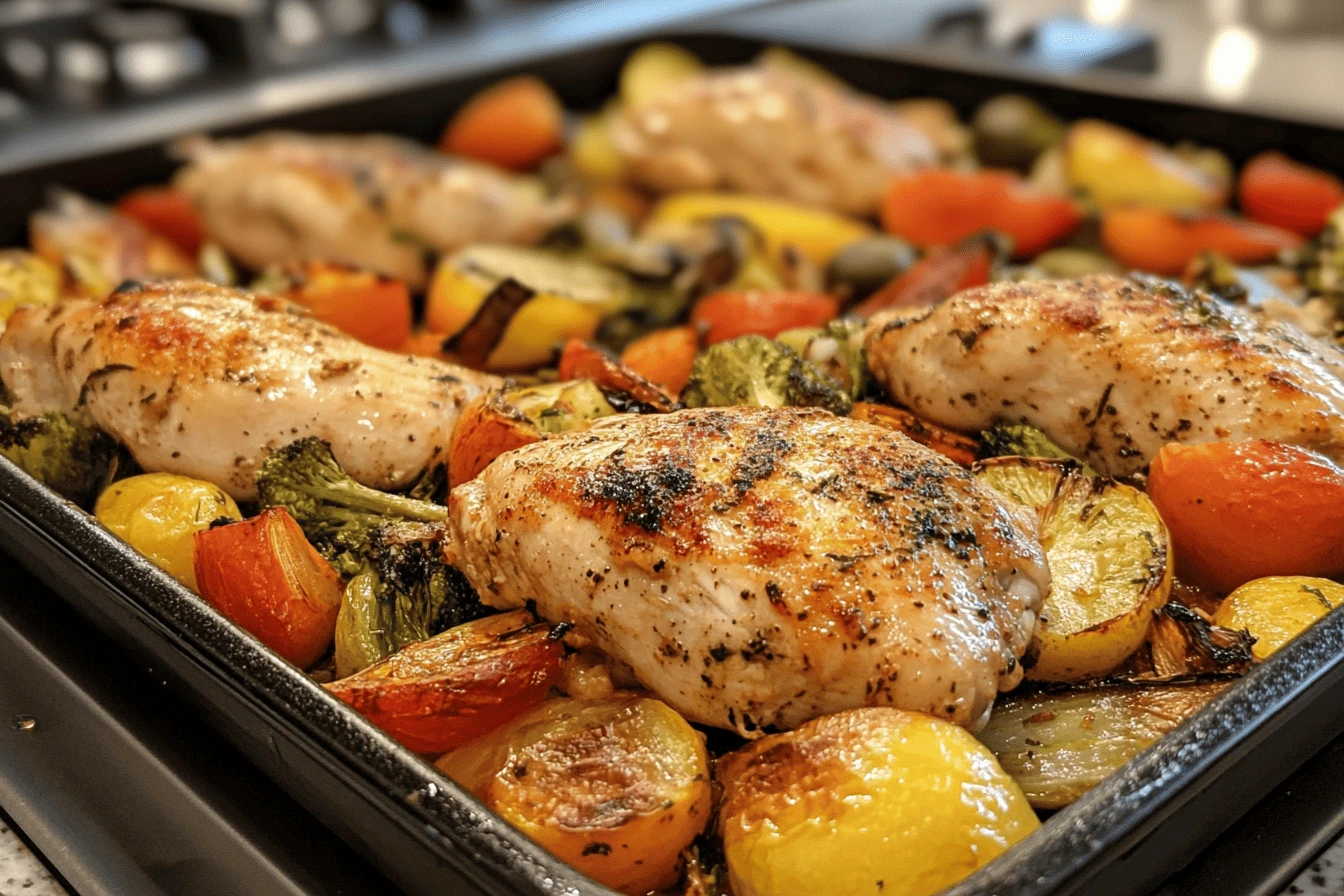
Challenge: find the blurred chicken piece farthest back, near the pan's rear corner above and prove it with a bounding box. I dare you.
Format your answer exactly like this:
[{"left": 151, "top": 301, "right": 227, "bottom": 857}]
[{"left": 612, "top": 66, "right": 938, "bottom": 215}]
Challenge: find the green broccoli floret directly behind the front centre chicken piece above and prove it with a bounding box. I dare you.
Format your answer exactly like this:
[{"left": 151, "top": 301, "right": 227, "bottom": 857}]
[{"left": 681, "top": 336, "right": 852, "bottom": 415}]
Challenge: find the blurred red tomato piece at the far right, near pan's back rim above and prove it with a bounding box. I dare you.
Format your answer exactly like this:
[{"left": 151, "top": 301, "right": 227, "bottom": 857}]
[{"left": 1236, "top": 152, "right": 1344, "bottom": 236}]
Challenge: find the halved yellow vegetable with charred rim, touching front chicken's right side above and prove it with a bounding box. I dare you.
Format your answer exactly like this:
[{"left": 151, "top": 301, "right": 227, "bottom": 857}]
[{"left": 976, "top": 458, "right": 1172, "bottom": 681}]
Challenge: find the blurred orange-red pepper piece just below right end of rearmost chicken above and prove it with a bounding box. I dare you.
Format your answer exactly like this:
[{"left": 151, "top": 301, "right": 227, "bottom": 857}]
[{"left": 882, "top": 168, "right": 1082, "bottom": 257}]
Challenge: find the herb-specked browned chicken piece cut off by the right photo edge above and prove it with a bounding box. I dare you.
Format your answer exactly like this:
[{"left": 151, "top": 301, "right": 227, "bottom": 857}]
[{"left": 867, "top": 277, "right": 1344, "bottom": 476}]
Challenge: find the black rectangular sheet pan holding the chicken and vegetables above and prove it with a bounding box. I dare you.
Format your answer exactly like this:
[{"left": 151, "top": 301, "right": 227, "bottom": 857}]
[{"left": 0, "top": 35, "right": 1344, "bottom": 896}]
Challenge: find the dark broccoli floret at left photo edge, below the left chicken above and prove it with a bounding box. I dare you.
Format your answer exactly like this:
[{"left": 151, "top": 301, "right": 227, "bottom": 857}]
[{"left": 0, "top": 408, "right": 120, "bottom": 509}]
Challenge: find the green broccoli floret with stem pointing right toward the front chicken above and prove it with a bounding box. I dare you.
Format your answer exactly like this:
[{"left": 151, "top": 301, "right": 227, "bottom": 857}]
[{"left": 257, "top": 437, "right": 448, "bottom": 575}]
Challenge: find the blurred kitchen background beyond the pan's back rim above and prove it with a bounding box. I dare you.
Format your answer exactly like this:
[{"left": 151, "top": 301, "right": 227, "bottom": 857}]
[{"left": 0, "top": 0, "right": 1344, "bottom": 155}]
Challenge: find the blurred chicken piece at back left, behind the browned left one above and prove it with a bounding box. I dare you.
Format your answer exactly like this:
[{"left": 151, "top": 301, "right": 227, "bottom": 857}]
[{"left": 176, "top": 133, "right": 573, "bottom": 289}]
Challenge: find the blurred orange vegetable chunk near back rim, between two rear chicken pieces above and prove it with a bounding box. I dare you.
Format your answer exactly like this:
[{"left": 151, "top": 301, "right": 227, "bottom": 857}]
[{"left": 438, "top": 75, "right": 564, "bottom": 171}]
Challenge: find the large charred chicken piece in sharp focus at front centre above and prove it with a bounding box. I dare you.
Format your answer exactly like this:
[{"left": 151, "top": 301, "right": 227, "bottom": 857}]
[{"left": 449, "top": 408, "right": 1050, "bottom": 736}]
